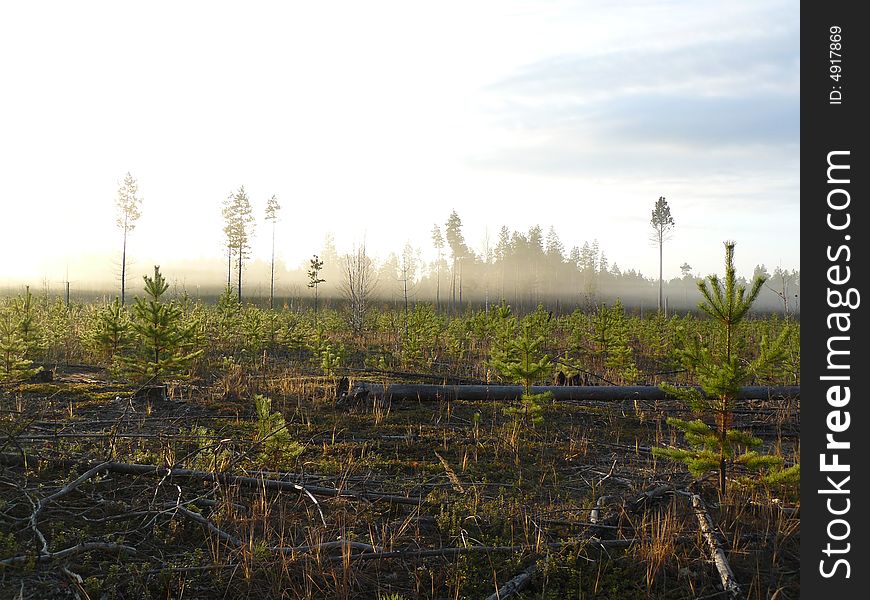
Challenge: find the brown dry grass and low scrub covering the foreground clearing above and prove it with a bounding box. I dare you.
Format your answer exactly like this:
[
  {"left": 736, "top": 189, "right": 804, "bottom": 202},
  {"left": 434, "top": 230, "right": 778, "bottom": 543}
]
[{"left": 0, "top": 369, "right": 799, "bottom": 600}]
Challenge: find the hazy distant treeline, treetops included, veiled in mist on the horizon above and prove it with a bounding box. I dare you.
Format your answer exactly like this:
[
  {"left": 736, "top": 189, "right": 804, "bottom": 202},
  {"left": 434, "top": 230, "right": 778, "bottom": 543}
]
[{"left": 0, "top": 219, "right": 800, "bottom": 315}]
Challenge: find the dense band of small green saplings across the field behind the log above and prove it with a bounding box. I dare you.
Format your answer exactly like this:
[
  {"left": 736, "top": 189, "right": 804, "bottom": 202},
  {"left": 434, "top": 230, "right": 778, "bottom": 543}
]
[{"left": 0, "top": 276, "right": 800, "bottom": 385}]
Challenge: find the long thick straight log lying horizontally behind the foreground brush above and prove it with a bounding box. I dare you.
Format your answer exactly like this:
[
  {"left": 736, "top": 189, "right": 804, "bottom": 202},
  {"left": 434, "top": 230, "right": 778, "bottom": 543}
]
[{"left": 350, "top": 381, "right": 800, "bottom": 401}]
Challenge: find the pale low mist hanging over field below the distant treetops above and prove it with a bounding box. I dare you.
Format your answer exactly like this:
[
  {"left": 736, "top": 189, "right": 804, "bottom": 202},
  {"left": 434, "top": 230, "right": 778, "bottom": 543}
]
[{"left": 0, "top": 238, "right": 800, "bottom": 315}]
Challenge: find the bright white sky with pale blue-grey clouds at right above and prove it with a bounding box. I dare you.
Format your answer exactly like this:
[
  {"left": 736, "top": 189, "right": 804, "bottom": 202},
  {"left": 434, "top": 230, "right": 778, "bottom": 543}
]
[{"left": 0, "top": 0, "right": 800, "bottom": 283}]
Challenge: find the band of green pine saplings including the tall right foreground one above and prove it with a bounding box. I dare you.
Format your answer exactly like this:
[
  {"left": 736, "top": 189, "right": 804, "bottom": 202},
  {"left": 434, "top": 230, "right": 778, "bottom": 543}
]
[{"left": 0, "top": 243, "right": 800, "bottom": 490}]
